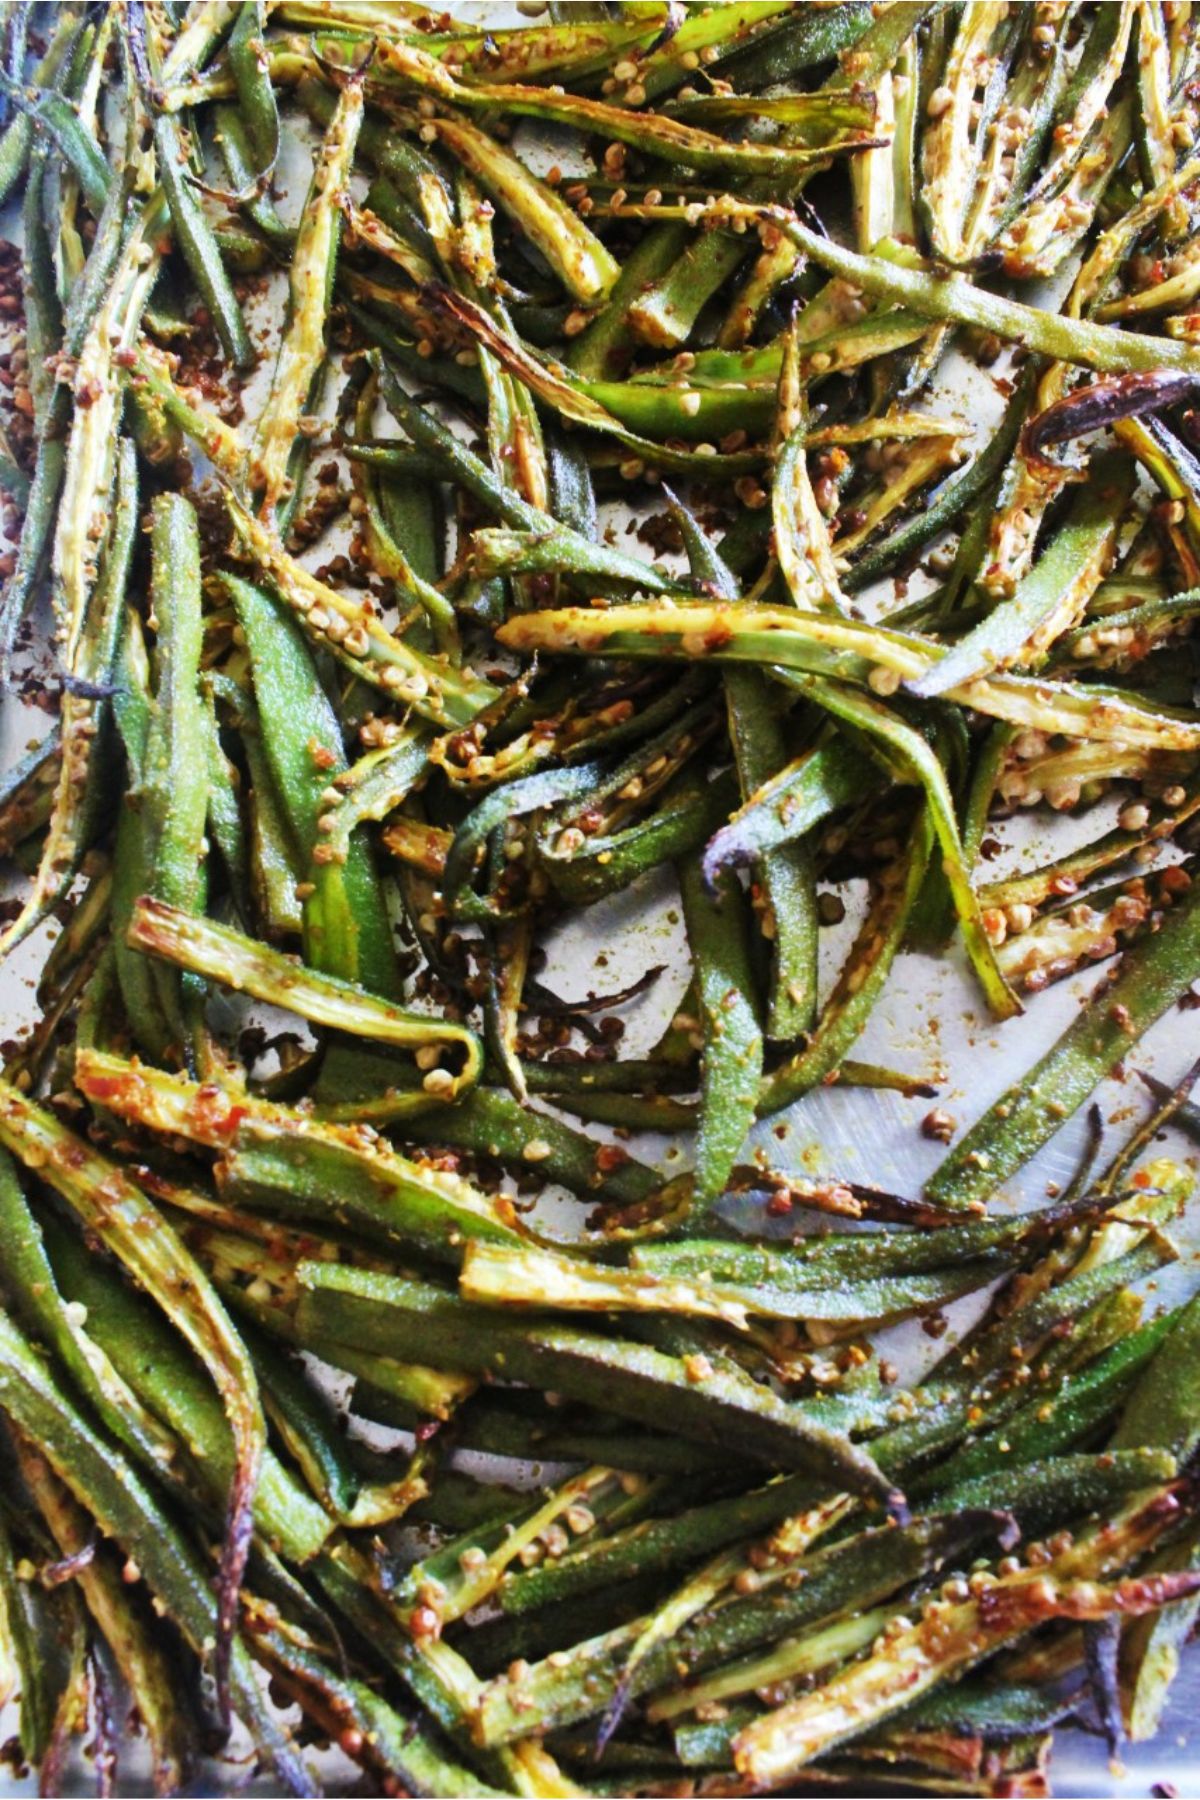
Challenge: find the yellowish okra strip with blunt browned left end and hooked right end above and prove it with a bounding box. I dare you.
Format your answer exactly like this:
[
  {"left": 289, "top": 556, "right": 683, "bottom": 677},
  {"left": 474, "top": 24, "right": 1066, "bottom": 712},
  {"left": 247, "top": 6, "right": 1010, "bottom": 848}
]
[{"left": 126, "top": 895, "right": 482, "bottom": 1100}]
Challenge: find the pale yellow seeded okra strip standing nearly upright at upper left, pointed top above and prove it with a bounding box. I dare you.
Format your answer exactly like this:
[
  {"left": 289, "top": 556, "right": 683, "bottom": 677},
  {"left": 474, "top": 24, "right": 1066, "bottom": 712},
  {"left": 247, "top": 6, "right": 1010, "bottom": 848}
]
[{"left": 248, "top": 67, "right": 363, "bottom": 518}]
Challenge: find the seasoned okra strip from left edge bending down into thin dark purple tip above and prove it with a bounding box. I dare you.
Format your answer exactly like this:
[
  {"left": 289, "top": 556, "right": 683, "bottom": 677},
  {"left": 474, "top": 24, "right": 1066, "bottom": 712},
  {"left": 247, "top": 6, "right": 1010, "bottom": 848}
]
[{"left": 0, "top": 1082, "right": 266, "bottom": 1706}]
